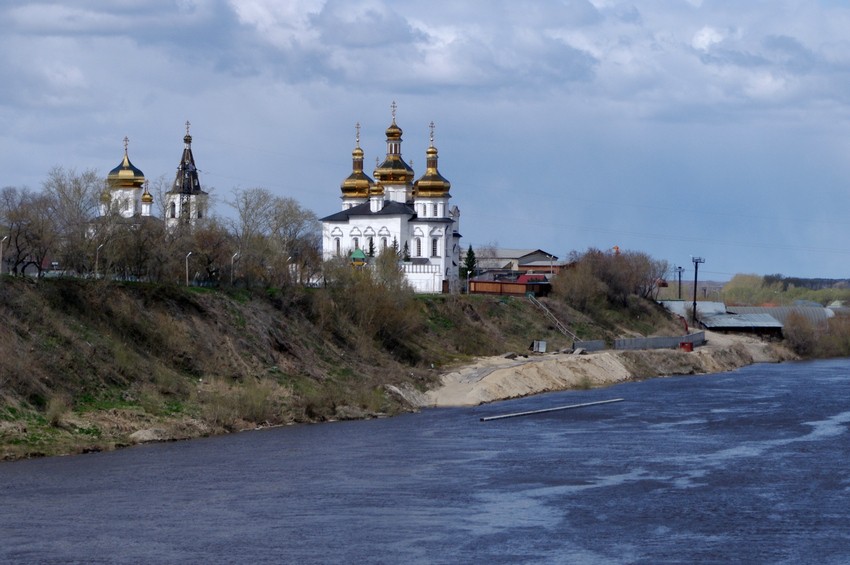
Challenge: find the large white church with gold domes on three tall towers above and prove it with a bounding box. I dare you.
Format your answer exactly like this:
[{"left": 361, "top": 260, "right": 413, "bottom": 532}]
[{"left": 321, "top": 102, "right": 460, "bottom": 293}]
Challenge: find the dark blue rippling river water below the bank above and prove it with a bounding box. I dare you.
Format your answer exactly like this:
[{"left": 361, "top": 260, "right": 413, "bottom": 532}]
[{"left": 0, "top": 359, "right": 850, "bottom": 564}]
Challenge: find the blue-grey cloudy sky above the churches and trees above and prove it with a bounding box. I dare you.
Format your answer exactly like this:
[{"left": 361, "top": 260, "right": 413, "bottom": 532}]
[{"left": 0, "top": 0, "right": 850, "bottom": 280}]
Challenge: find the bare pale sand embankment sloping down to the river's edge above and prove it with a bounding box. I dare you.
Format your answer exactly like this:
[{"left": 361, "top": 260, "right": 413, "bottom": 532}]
[{"left": 419, "top": 332, "right": 796, "bottom": 406}]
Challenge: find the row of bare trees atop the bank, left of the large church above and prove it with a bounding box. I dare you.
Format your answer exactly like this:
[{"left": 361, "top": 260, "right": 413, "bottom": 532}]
[{"left": 0, "top": 167, "right": 322, "bottom": 286}]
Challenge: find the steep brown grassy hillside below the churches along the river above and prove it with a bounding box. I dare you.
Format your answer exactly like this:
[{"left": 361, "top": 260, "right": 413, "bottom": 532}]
[{"left": 0, "top": 277, "right": 680, "bottom": 459}]
